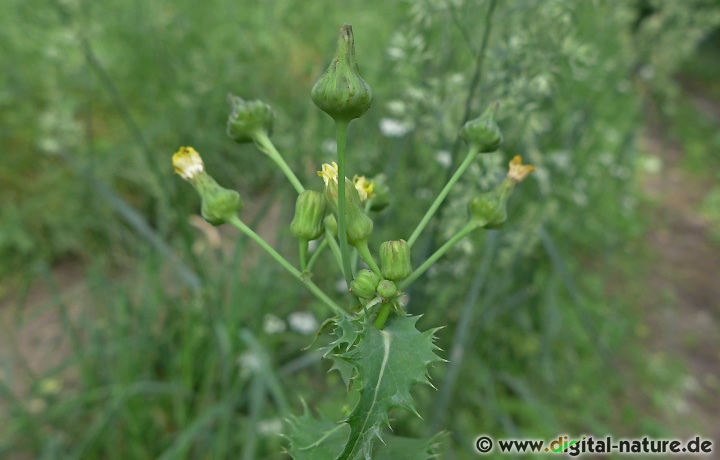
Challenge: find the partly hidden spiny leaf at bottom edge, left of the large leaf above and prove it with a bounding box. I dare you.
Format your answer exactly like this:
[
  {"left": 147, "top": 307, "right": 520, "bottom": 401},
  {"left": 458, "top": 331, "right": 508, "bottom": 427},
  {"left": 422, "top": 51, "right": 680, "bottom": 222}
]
[{"left": 286, "top": 406, "right": 348, "bottom": 460}]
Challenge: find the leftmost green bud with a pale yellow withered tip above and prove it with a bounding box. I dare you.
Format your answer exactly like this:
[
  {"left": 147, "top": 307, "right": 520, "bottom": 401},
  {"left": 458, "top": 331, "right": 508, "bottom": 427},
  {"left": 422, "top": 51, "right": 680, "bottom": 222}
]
[{"left": 173, "top": 147, "right": 243, "bottom": 225}]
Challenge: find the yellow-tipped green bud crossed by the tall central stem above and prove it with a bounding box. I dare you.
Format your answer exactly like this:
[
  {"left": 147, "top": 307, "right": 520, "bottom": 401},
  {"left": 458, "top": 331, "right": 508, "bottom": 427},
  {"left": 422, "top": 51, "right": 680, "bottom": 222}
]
[{"left": 319, "top": 163, "right": 373, "bottom": 246}]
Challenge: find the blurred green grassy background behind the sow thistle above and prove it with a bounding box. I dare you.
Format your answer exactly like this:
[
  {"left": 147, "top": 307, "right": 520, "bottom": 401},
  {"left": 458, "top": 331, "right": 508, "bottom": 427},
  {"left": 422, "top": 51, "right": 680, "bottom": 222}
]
[{"left": 0, "top": 0, "right": 720, "bottom": 459}]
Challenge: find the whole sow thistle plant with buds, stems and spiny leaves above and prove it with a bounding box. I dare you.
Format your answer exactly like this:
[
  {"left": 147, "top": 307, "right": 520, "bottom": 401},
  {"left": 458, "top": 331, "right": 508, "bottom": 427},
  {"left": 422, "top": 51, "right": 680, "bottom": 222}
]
[{"left": 172, "top": 25, "right": 534, "bottom": 460}]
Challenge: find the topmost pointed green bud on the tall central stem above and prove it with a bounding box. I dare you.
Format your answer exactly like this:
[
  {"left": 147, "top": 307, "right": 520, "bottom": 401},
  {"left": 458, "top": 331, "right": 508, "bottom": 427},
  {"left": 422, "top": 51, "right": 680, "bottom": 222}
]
[{"left": 310, "top": 24, "right": 373, "bottom": 122}]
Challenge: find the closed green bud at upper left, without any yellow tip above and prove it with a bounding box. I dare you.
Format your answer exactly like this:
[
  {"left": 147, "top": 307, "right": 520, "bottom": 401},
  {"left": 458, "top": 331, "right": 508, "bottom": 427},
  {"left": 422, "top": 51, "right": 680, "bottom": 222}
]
[{"left": 227, "top": 94, "right": 275, "bottom": 144}]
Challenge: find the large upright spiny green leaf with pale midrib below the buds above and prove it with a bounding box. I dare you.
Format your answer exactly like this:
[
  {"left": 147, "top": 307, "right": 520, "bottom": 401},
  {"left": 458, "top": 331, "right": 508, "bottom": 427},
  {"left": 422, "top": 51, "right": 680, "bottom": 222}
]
[{"left": 338, "top": 316, "right": 441, "bottom": 460}]
